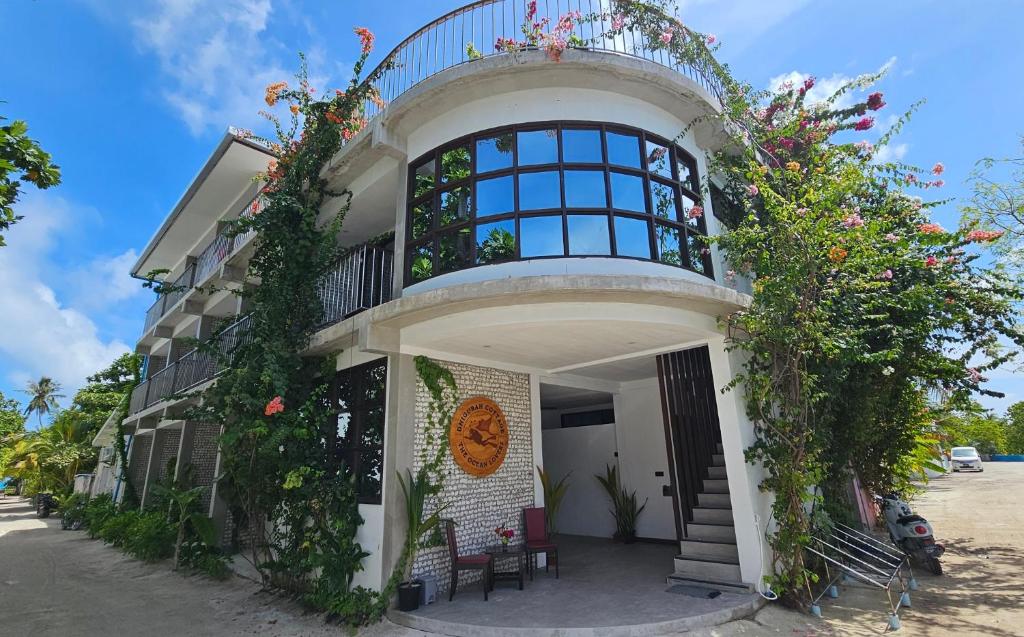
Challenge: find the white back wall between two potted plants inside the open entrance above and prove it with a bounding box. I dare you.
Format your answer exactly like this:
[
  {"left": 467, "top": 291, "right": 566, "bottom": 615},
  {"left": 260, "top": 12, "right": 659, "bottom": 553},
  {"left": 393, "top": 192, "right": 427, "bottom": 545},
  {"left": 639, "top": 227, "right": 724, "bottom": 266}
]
[{"left": 542, "top": 424, "right": 615, "bottom": 538}]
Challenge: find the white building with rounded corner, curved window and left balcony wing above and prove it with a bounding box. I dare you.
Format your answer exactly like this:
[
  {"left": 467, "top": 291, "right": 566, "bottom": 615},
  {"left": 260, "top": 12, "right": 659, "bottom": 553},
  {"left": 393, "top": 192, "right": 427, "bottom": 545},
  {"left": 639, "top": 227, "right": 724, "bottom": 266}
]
[{"left": 99, "top": 0, "right": 769, "bottom": 606}]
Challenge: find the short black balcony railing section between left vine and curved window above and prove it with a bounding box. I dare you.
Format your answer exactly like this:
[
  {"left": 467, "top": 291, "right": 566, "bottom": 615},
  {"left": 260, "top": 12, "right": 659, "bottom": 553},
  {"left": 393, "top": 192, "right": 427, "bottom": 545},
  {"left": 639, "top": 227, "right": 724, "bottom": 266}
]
[{"left": 318, "top": 245, "right": 394, "bottom": 327}]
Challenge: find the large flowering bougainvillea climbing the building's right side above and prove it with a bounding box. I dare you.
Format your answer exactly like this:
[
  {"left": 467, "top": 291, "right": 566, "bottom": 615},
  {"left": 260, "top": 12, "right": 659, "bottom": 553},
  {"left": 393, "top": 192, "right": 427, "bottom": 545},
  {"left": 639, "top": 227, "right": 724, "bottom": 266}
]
[{"left": 608, "top": 0, "right": 1024, "bottom": 603}]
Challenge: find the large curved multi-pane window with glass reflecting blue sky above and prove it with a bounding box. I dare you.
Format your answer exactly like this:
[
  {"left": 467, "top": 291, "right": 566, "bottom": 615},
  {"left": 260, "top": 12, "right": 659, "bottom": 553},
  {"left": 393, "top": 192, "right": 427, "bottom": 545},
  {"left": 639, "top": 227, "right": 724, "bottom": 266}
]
[{"left": 404, "top": 122, "right": 712, "bottom": 285}]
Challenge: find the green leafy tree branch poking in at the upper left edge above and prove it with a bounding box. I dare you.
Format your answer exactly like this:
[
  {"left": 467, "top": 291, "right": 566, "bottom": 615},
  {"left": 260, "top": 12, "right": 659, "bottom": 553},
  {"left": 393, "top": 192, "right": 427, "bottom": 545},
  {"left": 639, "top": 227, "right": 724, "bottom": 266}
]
[{"left": 0, "top": 116, "right": 60, "bottom": 247}]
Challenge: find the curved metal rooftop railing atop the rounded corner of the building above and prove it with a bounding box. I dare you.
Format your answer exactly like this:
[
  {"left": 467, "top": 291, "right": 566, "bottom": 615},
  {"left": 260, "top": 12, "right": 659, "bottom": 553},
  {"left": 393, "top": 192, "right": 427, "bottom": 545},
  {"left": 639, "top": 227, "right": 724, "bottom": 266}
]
[{"left": 366, "top": 0, "right": 723, "bottom": 118}]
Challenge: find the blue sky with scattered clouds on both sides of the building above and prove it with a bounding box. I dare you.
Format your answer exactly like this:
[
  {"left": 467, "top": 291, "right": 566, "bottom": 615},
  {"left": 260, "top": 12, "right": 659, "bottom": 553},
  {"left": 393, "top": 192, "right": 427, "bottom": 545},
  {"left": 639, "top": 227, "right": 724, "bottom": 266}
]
[{"left": 0, "top": 0, "right": 1024, "bottom": 423}]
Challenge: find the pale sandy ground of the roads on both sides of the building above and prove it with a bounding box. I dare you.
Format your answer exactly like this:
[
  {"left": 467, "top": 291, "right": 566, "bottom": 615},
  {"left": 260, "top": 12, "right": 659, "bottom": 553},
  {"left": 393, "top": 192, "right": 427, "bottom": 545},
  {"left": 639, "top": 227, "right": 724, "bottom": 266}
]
[{"left": 0, "top": 463, "right": 1024, "bottom": 637}]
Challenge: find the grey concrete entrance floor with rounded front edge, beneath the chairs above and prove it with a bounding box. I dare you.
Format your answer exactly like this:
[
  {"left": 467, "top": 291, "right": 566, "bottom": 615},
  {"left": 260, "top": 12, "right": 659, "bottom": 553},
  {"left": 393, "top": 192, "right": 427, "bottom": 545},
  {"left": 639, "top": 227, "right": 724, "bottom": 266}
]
[{"left": 389, "top": 536, "right": 758, "bottom": 636}]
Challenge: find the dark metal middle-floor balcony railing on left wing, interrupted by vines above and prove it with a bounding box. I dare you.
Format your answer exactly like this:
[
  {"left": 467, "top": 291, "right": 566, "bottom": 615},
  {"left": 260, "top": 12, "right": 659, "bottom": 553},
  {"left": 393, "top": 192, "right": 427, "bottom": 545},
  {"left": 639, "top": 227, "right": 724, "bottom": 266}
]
[{"left": 129, "top": 245, "right": 394, "bottom": 414}]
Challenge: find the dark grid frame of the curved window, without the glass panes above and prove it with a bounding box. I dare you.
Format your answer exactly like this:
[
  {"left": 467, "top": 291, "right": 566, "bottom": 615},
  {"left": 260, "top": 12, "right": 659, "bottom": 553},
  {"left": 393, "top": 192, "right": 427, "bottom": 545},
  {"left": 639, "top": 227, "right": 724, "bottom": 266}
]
[{"left": 402, "top": 120, "right": 714, "bottom": 287}]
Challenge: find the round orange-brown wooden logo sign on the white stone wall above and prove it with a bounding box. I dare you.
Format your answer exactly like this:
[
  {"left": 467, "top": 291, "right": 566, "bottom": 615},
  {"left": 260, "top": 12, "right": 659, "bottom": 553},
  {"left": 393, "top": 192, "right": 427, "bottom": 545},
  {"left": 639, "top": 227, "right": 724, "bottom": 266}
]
[{"left": 449, "top": 396, "right": 509, "bottom": 476}]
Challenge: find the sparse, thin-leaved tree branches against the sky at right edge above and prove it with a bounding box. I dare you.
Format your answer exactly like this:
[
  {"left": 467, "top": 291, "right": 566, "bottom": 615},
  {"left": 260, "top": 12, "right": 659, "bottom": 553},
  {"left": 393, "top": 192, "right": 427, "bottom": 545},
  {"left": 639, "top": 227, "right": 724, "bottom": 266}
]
[{"left": 962, "top": 136, "right": 1024, "bottom": 270}]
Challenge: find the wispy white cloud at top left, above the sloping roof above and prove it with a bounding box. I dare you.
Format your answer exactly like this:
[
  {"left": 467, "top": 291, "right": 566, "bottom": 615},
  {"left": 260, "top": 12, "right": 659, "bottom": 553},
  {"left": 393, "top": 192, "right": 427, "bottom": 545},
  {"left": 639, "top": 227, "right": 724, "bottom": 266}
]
[{"left": 131, "top": 0, "right": 295, "bottom": 135}]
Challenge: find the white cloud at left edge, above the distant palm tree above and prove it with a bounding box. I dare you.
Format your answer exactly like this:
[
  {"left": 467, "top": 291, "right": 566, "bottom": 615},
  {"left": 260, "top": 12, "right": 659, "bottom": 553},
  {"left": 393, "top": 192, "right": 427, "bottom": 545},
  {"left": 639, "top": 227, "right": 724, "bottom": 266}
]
[{"left": 0, "top": 193, "right": 138, "bottom": 397}]
